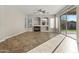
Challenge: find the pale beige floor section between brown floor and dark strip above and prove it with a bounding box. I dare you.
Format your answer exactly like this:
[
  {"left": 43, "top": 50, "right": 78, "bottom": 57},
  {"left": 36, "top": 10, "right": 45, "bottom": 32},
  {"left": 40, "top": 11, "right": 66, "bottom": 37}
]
[{"left": 28, "top": 34, "right": 65, "bottom": 53}]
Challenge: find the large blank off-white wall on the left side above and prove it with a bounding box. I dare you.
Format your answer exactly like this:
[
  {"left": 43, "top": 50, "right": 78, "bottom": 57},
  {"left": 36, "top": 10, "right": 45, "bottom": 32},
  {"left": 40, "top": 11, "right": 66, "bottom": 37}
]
[{"left": 0, "top": 6, "right": 25, "bottom": 41}]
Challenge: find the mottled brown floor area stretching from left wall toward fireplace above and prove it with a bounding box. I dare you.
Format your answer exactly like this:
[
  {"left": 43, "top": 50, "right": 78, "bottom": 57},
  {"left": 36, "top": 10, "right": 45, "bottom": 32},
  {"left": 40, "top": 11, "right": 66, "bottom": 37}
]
[{"left": 0, "top": 32, "right": 58, "bottom": 53}]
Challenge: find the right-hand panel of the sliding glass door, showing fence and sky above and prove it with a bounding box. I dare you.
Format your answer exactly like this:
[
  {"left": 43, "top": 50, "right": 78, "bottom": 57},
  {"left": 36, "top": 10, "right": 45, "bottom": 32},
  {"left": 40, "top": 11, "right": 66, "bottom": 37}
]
[{"left": 67, "top": 8, "right": 77, "bottom": 39}]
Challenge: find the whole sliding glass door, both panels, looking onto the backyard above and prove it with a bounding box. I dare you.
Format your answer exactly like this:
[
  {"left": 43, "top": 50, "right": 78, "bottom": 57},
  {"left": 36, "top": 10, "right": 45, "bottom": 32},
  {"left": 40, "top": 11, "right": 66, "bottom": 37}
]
[{"left": 60, "top": 8, "right": 77, "bottom": 39}]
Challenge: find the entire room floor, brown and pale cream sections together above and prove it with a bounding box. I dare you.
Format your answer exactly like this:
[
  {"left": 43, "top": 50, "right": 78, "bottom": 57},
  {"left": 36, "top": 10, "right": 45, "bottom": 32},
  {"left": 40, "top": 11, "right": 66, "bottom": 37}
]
[{"left": 0, "top": 32, "right": 78, "bottom": 53}]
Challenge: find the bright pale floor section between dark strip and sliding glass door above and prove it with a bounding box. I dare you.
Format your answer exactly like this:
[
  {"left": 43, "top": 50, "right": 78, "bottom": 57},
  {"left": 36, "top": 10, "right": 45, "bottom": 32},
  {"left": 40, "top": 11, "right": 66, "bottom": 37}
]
[{"left": 55, "top": 37, "right": 78, "bottom": 53}]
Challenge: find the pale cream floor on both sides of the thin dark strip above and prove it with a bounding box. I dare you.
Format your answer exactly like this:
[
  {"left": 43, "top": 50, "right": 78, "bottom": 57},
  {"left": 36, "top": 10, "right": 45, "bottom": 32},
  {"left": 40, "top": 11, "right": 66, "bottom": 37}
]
[{"left": 28, "top": 34, "right": 78, "bottom": 53}]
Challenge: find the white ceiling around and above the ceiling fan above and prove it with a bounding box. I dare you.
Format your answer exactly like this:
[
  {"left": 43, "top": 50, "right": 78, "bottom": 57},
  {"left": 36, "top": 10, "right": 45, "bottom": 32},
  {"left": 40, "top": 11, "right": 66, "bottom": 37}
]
[{"left": 17, "top": 5, "right": 65, "bottom": 15}]
